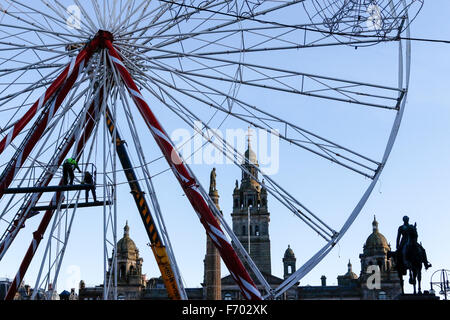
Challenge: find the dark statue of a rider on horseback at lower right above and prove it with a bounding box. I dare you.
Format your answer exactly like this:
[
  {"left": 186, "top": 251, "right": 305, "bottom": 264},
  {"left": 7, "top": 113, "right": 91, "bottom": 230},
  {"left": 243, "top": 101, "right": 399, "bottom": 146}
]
[{"left": 388, "top": 216, "right": 431, "bottom": 294}]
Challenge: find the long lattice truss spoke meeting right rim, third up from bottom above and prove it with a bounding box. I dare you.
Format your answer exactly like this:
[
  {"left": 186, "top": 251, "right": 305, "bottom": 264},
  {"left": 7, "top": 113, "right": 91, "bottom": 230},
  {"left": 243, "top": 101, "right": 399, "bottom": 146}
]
[{"left": 116, "top": 42, "right": 404, "bottom": 110}]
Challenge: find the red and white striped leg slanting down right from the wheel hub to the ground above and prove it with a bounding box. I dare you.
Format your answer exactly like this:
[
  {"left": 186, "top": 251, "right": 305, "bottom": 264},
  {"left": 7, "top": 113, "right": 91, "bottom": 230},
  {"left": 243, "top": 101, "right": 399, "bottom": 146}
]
[{"left": 105, "top": 40, "right": 262, "bottom": 300}]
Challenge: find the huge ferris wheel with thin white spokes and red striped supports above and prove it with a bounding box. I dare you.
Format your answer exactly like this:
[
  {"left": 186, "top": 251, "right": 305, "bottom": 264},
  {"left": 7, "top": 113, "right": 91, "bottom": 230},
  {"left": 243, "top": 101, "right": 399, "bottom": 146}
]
[{"left": 0, "top": 0, "right": 423, "bottom": 299}]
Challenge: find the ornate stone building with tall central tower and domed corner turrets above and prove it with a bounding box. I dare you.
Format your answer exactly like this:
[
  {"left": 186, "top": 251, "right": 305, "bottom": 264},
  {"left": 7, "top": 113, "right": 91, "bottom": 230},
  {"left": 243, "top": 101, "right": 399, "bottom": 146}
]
[{"left": 79, "top": 141, "right": 401, "bottom": 300}]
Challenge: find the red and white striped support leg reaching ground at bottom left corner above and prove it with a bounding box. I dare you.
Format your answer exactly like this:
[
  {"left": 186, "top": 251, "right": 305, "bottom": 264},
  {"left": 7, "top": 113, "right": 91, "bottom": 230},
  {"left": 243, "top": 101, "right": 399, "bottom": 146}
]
[{"left": 5, "top": 87, "right": 103, "bottom": 300}]
